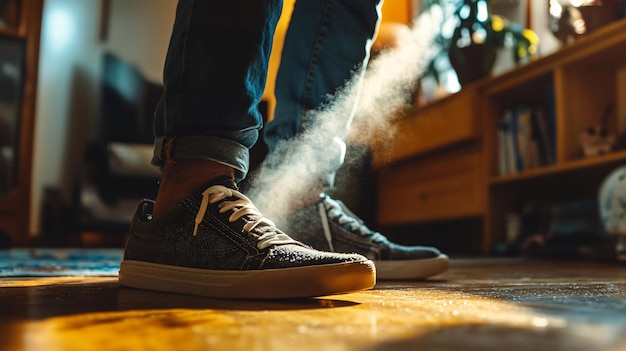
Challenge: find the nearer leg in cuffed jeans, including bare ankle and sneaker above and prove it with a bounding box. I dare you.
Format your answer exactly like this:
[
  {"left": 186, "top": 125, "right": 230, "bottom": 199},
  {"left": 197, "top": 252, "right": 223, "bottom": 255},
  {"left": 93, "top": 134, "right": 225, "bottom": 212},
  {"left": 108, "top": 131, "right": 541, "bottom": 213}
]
[{"left": 119, "top": 0, "right": 375, "bottom": 298}]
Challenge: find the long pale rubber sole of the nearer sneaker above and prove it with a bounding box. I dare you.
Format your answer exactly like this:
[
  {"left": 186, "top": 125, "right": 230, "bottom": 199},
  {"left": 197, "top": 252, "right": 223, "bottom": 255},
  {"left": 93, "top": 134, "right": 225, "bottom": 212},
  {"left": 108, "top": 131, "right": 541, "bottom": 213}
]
[{"left": 119, "top": 260, "right": 376, "bottom": 299}]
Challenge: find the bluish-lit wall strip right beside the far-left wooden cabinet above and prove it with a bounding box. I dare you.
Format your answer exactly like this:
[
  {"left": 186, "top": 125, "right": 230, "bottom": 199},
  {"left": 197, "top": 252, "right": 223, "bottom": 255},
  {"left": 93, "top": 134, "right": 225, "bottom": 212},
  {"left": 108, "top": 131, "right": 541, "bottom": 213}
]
[{"left": 30, "top": 0, "right": 100, "bottom": 233}]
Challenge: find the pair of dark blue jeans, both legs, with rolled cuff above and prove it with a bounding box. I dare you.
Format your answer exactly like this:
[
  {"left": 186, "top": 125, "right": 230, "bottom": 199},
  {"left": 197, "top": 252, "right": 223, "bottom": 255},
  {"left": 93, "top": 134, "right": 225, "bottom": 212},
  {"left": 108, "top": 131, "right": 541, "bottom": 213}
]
[{"left": 153, "top": 0, "right": 382, "bottom": 184}]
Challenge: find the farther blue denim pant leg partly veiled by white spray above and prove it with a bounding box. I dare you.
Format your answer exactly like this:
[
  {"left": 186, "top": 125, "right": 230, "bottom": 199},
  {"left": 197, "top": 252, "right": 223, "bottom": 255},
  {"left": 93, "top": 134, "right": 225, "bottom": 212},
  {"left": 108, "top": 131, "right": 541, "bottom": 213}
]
[{"left": 264, "top": 0, "right": 383, "bottom": 185}]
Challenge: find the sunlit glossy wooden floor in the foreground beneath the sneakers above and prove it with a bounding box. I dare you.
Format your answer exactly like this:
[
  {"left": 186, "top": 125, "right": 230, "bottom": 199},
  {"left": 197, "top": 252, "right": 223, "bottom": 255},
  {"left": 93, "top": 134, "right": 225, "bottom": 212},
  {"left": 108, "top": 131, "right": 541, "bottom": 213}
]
[{"left": 0, "top": 259, "right": 626, "bottom": 351}]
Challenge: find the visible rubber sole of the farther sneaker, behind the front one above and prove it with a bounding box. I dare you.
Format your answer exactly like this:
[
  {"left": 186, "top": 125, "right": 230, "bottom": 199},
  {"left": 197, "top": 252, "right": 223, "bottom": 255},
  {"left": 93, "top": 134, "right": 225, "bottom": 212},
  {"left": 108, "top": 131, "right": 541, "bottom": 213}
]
[{"left": 374, "top": 254, "right": 450, "bottom": 280}]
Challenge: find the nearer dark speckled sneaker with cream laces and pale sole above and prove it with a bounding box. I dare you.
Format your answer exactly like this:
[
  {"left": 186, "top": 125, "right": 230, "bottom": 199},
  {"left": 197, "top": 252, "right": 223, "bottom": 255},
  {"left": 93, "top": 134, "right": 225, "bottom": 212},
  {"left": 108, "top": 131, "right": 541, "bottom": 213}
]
[{"left": 119, "top": 180, "right": 376, "bottom": 298}]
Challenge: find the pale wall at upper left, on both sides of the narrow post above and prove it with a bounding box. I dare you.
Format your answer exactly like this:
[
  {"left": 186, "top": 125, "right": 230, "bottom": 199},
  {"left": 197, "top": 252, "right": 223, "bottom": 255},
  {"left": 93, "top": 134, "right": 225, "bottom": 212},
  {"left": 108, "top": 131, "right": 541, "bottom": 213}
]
[{"left": 30, "top": 0, "right": 177, "bottom": 235}]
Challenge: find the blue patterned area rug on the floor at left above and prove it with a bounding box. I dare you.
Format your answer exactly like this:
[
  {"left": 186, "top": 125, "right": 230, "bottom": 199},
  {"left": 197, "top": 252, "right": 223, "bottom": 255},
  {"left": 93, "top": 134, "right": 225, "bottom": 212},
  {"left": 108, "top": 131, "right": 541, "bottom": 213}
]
[{"left": 0, "top": 249, "right": 123, "bottom": 277}]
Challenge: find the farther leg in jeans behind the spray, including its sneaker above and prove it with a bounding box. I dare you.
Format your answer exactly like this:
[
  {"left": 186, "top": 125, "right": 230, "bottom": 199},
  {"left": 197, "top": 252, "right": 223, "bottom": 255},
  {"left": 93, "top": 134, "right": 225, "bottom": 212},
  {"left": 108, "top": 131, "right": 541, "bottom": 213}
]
[{"left": 264, "top": 0, "right": 449, "bottom": 279}]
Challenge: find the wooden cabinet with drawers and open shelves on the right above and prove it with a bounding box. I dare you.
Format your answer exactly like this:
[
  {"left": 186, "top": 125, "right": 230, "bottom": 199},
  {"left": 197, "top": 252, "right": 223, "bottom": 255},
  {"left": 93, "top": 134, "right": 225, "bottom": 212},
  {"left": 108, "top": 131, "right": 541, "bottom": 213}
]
[{"left": 375, "top": 20, "right": 626, "bottom": 253}]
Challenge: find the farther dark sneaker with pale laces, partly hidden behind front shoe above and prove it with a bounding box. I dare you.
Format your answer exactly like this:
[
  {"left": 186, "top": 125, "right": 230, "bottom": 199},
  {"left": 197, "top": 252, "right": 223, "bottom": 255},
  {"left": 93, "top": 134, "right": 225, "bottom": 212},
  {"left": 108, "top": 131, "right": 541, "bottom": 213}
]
[{"left": 277, "top": 194, "right": 449, "bottom": 280}]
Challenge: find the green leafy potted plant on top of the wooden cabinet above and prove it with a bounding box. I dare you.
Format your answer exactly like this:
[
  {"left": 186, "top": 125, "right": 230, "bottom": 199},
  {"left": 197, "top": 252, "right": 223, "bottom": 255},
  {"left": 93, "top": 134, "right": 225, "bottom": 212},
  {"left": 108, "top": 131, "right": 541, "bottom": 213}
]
[{"left": 424, "top": 0, "right": 539, "bottom": 85}]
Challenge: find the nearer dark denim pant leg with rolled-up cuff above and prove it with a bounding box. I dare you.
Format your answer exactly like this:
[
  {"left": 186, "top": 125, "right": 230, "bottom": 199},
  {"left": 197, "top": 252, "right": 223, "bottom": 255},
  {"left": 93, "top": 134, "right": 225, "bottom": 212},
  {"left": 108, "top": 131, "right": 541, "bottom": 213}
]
[{"left": 153, "top": 0, "right": 282, "bottom": 180}]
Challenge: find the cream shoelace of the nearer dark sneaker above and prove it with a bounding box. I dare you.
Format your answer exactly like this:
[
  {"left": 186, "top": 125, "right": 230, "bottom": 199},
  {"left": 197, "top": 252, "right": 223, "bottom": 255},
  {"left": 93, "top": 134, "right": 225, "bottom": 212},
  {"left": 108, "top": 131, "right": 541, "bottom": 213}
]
[{"left": 193, "top": 185, "right": 298, "bottom": 250}]
